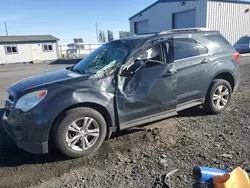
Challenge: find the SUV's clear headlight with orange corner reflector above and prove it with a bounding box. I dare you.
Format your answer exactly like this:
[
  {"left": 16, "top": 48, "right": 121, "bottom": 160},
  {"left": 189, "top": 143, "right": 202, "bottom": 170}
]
[{"left": 15, "top": 90, "right": 47, "bottom": 112}]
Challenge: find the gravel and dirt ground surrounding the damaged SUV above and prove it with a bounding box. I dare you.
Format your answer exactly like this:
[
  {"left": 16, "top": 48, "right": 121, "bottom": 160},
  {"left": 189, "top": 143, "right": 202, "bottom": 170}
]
[{"left": 0, "top": 58, "right": 250, "bottom": 188}]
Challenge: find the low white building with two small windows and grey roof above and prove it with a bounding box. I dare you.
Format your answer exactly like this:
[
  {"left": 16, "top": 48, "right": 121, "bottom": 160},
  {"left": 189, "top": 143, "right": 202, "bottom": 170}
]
[{"left": 0, "top": 35, "right": 59, "bottom": 64}]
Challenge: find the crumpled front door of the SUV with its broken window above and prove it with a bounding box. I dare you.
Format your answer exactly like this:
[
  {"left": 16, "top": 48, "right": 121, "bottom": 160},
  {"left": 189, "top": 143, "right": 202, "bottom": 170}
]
[{"left": 116, "top": 43, "right": 177, "bottom": 129}]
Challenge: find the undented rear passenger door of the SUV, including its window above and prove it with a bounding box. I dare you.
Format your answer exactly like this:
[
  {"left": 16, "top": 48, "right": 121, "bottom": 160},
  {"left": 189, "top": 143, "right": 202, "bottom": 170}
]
[{"left": 173, "top": 37, "right": 210, "bottom": 106}]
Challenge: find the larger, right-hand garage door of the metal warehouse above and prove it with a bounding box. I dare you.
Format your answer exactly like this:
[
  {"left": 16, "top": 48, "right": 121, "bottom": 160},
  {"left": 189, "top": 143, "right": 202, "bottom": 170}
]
[{"left": 173, "top": 10, "right": 196, "bottom": 29}]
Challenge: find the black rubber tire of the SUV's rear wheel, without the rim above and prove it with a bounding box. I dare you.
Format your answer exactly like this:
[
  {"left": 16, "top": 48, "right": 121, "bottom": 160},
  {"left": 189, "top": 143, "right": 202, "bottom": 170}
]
[{"left": 204, "top": 79, "right": 232, "bottom": 114}]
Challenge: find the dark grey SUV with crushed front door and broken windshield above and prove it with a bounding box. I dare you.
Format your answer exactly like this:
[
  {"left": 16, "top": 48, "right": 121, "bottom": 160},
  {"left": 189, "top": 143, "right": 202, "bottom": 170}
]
[{"left": 3, "top": 29, "right": 240, "bottom": 157}]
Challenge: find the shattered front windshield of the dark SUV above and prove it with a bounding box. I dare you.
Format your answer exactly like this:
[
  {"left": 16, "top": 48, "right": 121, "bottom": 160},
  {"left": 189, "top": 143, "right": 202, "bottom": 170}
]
[{"left": 72, "top": 41, "right": 129, "bottom": 74}]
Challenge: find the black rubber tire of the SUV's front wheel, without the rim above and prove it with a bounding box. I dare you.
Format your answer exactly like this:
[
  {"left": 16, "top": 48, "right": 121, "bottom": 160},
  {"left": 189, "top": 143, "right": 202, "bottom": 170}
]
[{"left": 54, "top": 107, "right": 107, "bottom": 158}]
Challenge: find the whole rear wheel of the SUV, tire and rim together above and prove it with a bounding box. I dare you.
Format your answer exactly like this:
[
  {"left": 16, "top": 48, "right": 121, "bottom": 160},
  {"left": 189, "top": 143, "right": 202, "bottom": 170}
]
[{"left": 204, "top": 79, "right": 232, "bottom": 114}]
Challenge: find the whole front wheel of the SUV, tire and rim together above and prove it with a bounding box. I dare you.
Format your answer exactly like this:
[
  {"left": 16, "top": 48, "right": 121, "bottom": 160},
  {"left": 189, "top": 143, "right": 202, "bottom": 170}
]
[{"left": 55, "top": 107, "right": 107, "bottom": 158}]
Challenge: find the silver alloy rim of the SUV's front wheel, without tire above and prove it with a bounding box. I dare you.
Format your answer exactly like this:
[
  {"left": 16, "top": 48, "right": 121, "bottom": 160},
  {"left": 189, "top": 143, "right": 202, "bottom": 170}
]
[{"left": 66, "top": 117, "right": 100, "bottom": 151}]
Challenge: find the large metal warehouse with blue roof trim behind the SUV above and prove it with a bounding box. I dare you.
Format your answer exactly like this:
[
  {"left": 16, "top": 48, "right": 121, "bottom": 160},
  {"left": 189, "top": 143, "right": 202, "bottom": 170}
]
[{"left": 129, "top": 0, "right": 250, "bottom": 44}]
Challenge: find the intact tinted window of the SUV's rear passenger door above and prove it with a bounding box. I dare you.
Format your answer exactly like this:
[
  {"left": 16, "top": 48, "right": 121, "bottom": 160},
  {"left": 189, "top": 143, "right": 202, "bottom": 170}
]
[{"left": 172, "top": 38, "right": 208, "bottom": 60}]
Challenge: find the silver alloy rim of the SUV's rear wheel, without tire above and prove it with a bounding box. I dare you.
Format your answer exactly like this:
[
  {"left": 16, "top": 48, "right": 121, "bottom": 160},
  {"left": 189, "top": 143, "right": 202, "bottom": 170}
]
[{"left": 213, "top": 85, "right": 229, "bottom": 110}]
